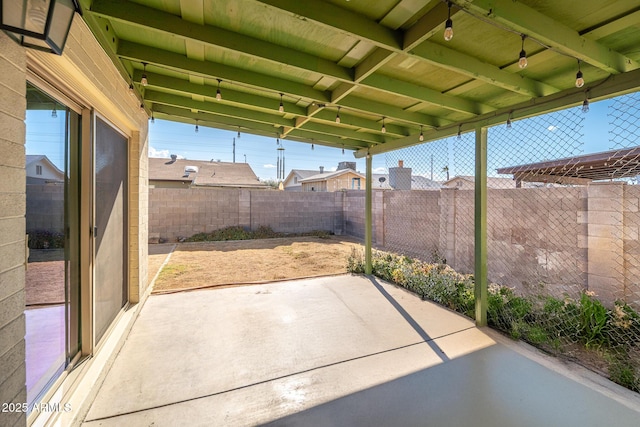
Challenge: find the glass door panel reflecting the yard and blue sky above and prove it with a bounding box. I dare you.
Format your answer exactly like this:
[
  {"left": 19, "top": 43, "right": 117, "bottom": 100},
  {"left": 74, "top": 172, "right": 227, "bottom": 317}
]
[{"left": 25, "top": 84, "right": 80, "bottom": 408}]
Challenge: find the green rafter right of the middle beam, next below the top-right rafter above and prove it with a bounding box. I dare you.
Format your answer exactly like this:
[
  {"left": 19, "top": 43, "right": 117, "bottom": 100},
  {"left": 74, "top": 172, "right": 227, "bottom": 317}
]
[{"left": 410, "top": 41, "right": 558, "bottom": 97}]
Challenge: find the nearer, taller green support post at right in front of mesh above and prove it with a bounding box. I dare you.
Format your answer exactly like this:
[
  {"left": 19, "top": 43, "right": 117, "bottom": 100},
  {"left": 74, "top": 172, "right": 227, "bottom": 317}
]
[{"left": 474, "top": 128, "right": 488, "bottom": 326}]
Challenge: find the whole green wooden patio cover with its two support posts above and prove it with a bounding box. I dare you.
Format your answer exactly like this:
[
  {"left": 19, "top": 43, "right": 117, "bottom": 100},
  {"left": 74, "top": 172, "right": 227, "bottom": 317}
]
[{"left": 80, "top": 0, "right": 640, "bottom": 324}]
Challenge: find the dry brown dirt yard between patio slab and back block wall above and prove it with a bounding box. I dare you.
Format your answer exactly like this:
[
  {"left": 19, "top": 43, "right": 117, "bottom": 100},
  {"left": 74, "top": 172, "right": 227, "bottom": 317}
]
[{"left": 149, "top": 236, "right": 362, "bottom": 293}]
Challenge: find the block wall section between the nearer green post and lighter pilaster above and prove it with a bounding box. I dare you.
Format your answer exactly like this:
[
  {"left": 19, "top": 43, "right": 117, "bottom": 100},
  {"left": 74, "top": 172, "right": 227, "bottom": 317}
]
[{"left": 487, "top": 187, "right": 587, "bottom": 297}]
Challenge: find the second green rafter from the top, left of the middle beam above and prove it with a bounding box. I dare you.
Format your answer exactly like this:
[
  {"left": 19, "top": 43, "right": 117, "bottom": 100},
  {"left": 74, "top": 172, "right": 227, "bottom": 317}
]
[{"left": 117, "top": 41, "right": 329, "bottom": 102}]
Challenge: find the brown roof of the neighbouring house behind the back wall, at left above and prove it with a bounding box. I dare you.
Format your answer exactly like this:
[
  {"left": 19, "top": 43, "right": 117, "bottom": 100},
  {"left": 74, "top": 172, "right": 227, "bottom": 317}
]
[{"left": 149, "top": 158, "right": 267, "bottom": 188}]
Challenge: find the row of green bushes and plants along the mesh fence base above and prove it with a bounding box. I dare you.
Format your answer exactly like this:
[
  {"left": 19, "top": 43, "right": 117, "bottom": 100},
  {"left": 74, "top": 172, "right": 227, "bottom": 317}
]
[{"left": 347, "top": 250, "right": 640, "bottom": 392}]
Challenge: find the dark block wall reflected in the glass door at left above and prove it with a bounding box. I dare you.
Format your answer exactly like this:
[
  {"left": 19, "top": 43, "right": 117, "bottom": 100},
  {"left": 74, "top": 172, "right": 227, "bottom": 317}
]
[{"left": 27, "top": 183, "right": 64, "bottom": 233}]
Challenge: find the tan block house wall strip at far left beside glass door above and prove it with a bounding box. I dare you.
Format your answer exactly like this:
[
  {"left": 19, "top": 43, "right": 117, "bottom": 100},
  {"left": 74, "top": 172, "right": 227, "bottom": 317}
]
[{"left": 0, "top": 32, "right": 27, "bottom": 426}]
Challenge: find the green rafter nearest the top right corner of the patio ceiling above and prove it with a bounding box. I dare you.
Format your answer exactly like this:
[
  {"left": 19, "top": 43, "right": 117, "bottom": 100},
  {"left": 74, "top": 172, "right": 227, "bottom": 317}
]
[{"left": 454, "top": 0, "right": 640, "bottom": 74}]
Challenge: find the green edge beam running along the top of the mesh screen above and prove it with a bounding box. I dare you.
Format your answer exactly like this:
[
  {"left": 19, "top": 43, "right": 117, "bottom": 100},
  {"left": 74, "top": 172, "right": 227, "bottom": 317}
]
[{"left": 354, "top": 69, "right": 640, "bottom": 158}]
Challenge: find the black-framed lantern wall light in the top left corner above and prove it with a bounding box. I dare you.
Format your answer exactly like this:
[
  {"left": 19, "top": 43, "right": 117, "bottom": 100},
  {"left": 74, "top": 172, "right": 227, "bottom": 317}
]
[{"left": 0, "top": 0, "right": 80, "bottom": 55}]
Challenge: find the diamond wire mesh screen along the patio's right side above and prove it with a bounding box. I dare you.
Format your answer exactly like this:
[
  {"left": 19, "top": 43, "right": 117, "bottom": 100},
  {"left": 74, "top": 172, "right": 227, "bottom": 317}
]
[{"left": 377, "top": 93, "right": 640, "bottom": 391}]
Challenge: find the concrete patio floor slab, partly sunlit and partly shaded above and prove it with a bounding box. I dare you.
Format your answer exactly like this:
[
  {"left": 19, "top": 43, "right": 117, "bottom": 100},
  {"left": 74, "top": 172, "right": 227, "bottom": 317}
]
[{"left": 83, "top": 275, "right": 640, "bottom": 427}]
